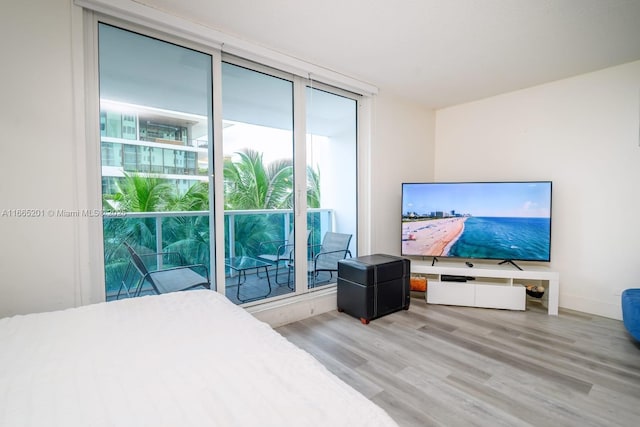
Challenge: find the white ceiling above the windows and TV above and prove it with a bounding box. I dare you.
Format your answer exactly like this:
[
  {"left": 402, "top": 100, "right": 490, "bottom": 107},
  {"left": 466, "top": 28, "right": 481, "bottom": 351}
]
[{"left": 136, "top": 0, "right": 640, "bottom": 108}]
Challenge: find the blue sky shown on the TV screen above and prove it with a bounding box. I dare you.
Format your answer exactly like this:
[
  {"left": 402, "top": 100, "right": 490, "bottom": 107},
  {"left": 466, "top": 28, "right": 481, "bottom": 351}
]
[{"left": 402, "top": 182, "right": 551, "bottom": 218}]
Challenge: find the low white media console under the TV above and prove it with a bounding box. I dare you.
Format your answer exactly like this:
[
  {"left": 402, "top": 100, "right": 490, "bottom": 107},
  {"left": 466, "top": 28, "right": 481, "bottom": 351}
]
[{"left": 411, "top": 260, "right": 560, "bottom": 316}]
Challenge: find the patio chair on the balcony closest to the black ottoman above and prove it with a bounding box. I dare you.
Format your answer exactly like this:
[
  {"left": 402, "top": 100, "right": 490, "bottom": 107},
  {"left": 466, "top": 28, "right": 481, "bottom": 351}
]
[{"left": 287, "top": 231, "right": 352, "bottom": 287}]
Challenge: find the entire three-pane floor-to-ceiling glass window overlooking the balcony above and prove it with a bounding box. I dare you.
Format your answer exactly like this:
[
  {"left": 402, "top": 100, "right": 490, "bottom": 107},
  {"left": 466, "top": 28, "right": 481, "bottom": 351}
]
[{"left": 98, "top": 19, "right": 358, "bottom": 304}]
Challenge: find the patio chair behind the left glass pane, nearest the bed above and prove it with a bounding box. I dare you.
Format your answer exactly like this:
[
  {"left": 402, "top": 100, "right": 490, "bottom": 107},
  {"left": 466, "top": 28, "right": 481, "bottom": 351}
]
[{"left": 116, "top": 242, "right": 211, "bottom": 299}]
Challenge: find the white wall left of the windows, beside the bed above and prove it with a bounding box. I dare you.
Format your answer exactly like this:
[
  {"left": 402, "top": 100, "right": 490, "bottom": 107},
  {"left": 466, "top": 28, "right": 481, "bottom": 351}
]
[{"left": 0, "top": 0, "right": 94, "bottom": 317}]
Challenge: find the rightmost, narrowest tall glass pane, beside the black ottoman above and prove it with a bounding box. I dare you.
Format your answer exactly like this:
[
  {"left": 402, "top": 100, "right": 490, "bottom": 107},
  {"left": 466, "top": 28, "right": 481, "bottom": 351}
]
[{"left": 305, "top": 82, "right": 358, "bottom": 287}]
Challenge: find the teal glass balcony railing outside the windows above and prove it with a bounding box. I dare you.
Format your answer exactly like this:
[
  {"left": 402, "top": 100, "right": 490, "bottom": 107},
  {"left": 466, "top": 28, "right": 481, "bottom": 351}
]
[{"left": 103, "top": 209, "right": 334, "bottom": 299}]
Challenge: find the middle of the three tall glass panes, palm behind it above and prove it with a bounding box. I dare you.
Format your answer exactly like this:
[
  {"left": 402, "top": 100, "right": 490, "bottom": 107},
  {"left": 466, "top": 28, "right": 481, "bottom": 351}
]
[{"left": 222, "top": 62, "right": 295, "bottom": 303}]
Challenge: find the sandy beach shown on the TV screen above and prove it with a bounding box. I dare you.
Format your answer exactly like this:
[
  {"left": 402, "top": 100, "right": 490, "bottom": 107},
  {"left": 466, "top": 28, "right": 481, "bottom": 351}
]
[{"left": 402, "top": 217, "right": 467, "bottom": 256}]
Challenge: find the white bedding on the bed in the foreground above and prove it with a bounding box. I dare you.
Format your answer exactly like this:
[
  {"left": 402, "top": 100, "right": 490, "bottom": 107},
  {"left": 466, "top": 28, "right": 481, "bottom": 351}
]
[{"left": 0, "top": 290, "right": 396, "bottom": 427}]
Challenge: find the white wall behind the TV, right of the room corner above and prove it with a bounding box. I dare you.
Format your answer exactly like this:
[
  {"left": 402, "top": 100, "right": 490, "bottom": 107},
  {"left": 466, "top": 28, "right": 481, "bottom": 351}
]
[{"left": 435, "top": 61, "right": 640, "bottom": 319}]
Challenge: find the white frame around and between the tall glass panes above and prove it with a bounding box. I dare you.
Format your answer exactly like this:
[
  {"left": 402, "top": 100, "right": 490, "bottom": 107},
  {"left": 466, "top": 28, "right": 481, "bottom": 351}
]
[{"left": 82, "top": 7, "right": 370, "bottom": 307}]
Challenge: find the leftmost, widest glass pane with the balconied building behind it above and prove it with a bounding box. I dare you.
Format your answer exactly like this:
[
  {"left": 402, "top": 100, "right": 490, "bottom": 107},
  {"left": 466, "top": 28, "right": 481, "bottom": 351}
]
[{"left": 98, "top": 23, "right": 215, "bottom": 300}]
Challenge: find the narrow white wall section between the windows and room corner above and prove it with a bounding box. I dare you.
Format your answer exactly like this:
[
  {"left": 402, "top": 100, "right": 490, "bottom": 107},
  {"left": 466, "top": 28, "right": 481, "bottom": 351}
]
[{"left": 368, "top": 90, "right": 435, "bottom": 255}]
